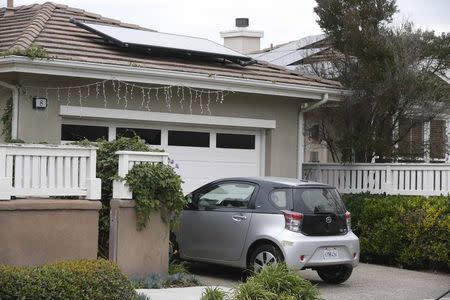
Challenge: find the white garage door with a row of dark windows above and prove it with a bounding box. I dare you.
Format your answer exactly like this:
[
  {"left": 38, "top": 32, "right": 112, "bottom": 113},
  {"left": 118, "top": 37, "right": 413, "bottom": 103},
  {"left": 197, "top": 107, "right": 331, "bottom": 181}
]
[{"left": 61, "top": 118, "right": 264, "bottom": 194}]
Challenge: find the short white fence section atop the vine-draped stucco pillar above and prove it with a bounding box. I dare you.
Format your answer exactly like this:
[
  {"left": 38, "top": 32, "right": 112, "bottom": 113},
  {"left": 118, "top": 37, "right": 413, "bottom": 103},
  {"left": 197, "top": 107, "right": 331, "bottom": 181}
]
[{"left": 113, "top": 151, "right": 169, "bottom": 199}]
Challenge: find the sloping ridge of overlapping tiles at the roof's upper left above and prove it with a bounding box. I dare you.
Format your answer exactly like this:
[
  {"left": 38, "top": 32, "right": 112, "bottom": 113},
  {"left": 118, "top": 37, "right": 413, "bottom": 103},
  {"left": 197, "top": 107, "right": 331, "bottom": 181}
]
[{"left": 9, "top": 2, "right": 56, "bottom": 50}]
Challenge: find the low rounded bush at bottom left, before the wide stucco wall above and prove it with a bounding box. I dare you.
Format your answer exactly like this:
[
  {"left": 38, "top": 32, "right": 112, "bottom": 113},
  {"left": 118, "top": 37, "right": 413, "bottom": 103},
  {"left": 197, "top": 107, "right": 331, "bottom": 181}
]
[{"left": 0, "top": 259, "right": 137, "bottom": 300}]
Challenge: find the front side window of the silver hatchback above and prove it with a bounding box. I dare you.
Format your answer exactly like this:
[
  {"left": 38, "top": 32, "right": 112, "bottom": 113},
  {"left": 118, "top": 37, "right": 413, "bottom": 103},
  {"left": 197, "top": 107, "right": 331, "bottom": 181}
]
[{"left": 197, "top": 182, "right": 256, "bottom": 209}]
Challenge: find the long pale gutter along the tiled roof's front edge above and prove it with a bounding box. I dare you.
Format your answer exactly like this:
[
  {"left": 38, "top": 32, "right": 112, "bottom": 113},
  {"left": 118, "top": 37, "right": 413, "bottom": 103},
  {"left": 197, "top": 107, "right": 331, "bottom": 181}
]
[{"left": 0, "top": 56, "right": 349, "bottom": 101}]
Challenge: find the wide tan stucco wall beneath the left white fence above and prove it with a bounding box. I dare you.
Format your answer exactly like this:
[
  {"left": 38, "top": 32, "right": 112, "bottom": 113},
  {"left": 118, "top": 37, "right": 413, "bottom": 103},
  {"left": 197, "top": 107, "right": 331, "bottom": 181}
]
[{"left": 0, "top": 199, "right": 101, "bottom": 266}]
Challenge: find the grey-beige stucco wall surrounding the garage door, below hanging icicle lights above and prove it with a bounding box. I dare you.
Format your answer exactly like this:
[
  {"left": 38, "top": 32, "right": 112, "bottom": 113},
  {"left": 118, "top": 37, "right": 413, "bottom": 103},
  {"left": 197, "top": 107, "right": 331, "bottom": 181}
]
[{"left": 14, "top": 74, "right": 300, "bottom": 177}]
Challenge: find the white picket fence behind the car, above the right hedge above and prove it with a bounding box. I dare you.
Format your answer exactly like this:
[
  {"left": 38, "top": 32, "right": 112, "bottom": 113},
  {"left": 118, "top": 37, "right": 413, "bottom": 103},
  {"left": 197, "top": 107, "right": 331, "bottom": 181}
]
[{"left": 303, "top": 163, "right": 450, "bottom": 196}]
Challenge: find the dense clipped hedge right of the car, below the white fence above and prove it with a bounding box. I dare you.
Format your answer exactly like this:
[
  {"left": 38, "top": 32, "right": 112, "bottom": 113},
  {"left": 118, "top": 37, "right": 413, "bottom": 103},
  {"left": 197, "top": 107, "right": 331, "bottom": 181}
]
[{"left": 344, "top": 194, "right": 450, "bottom": 271}]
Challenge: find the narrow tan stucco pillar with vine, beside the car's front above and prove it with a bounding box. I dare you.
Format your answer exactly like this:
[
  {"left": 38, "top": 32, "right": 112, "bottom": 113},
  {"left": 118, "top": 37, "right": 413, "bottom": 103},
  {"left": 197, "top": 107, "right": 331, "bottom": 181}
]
[{"left": 109, "top": 199, "right": 169, "bottom": 276}]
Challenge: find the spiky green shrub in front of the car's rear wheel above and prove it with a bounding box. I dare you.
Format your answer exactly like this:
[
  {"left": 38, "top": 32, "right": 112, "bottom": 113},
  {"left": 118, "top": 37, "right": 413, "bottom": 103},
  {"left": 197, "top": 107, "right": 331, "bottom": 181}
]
[{"left": 233, "top": 264, "right": 321, "bottom": 300}]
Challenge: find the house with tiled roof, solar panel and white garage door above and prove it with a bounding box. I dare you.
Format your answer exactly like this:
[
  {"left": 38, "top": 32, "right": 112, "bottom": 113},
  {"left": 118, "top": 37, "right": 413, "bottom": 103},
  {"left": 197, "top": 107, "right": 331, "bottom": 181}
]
[{"left": 0, "top": 1, "right": 343, "bottom": 192}]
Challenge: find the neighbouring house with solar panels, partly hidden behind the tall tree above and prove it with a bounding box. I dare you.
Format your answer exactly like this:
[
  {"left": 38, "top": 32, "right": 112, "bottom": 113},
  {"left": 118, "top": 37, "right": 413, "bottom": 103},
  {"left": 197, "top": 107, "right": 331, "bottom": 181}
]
[{"left": 251, "top": 34, "right": 450, "bottom": 163}]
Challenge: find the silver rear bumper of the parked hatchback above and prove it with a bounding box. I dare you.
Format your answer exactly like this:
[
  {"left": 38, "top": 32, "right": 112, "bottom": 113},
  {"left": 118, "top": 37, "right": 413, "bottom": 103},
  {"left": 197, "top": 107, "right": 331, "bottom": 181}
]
[{"left": 279, "top": 230, "right": 359, "bottom": 270}]
